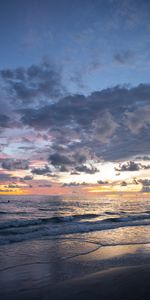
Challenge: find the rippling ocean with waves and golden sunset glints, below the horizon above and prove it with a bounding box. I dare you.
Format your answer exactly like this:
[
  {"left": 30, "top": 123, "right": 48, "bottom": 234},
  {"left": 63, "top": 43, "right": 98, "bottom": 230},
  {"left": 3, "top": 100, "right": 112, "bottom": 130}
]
[{"left": 0, "top": 194, "right": 150, "bottom": 247}]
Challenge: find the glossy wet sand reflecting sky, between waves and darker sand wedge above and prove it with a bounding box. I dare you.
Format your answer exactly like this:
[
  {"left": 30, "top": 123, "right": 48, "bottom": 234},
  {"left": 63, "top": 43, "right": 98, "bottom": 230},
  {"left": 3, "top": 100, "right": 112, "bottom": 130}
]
[{"left": 0, "top": 227, "right": 150, "bottom": 300}]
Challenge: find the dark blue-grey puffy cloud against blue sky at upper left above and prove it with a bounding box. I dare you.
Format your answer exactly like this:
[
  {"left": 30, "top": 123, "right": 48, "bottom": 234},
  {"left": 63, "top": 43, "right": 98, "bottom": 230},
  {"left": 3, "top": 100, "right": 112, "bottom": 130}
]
[{"left": 0, "top": 62, "right": 63, "bottom": 104}]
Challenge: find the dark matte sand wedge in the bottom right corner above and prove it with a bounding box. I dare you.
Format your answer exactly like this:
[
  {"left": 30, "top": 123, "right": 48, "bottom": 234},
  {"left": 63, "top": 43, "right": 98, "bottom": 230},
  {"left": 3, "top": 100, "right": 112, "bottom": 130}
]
[{"left": 48, "top": 265, "right": 150, "bottom": 300}]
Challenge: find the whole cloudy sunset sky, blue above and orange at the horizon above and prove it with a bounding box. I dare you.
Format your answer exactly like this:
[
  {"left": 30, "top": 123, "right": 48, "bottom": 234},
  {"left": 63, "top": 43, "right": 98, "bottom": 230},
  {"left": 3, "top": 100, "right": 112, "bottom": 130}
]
[{"left": 0, "top": 0, "right": 150, "bottom": 195}]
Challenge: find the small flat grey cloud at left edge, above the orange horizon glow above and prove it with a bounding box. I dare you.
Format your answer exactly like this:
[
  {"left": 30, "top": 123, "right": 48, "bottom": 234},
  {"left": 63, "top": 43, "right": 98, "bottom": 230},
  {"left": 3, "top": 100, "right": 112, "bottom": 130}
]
[{"left": 1, "top": 159, "right": 29, "bottom": 170}]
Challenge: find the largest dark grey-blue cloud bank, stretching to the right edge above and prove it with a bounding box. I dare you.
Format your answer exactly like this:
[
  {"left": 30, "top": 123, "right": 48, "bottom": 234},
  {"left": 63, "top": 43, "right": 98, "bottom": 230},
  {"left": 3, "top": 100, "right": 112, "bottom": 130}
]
[{"left": 20, "top": 84, "right": 150, "bottom": 164}]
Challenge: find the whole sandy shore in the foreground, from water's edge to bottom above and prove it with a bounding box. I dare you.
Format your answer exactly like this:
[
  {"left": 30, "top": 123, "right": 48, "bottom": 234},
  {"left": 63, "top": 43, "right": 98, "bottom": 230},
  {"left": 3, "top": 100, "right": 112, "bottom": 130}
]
[{"left": 0, "top": 233, "right": 150, "bottom": 300}]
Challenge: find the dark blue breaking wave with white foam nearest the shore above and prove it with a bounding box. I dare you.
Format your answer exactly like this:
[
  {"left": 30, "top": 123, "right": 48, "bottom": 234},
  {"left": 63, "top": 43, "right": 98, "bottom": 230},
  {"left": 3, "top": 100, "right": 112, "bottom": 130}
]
[{"left": 0, "top": 214, "right": 150, "bottom": 244}]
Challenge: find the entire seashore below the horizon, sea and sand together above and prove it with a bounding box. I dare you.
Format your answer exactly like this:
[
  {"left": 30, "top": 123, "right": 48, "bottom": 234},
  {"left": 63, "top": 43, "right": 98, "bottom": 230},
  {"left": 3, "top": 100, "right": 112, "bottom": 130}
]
[{"left": 0, "top": 196, "right": 150, "bottom": 300}]
